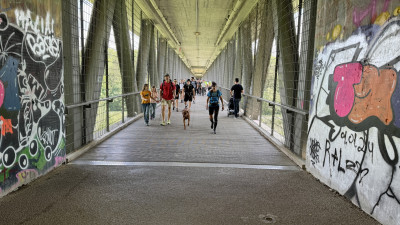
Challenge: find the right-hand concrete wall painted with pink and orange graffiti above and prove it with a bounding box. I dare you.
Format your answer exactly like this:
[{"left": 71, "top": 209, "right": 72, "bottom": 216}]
[{"left": 307, "top": 0, "right": 400, "bottom": 224}]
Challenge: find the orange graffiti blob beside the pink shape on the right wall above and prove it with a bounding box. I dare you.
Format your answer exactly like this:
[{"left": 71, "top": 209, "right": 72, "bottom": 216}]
[{"left": 348, "top": 65, "right": 397, "bottom": 125}]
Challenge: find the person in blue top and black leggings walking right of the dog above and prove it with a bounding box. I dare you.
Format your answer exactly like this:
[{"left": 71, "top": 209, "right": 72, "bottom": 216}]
[{"left": 206, "top": 82, "right": 224, "bottom": 134}]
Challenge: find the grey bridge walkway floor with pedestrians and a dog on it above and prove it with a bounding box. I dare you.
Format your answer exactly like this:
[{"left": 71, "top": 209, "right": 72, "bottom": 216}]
[{"left": 0, "top": 97, "right": 376, "bottom": 225}]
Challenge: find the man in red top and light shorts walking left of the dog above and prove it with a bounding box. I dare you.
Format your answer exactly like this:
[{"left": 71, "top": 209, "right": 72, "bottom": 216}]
[{"left": 160, "top": 74, "right": 175, "bottom": 126}]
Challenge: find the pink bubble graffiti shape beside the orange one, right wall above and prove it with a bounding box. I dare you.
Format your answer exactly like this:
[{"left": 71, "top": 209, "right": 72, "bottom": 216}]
[{"left": 333, "top": 63, "right": 362, "bottom": 117}]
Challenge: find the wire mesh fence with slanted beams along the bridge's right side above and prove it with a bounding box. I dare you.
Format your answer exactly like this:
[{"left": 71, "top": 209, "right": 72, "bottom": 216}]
[{"left": 204, "top": 0, "right": 317, "bottom": 158}]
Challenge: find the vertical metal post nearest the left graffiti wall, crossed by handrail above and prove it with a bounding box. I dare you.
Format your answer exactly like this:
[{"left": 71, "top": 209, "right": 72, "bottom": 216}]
[{"left": 80, "top": 0, "right": 86, "bottom": 145}]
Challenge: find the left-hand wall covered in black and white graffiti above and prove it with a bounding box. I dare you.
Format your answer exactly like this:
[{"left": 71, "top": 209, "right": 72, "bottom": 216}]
[{"left": 0, "top": 0, "right": 65, "bottom": 196}]
